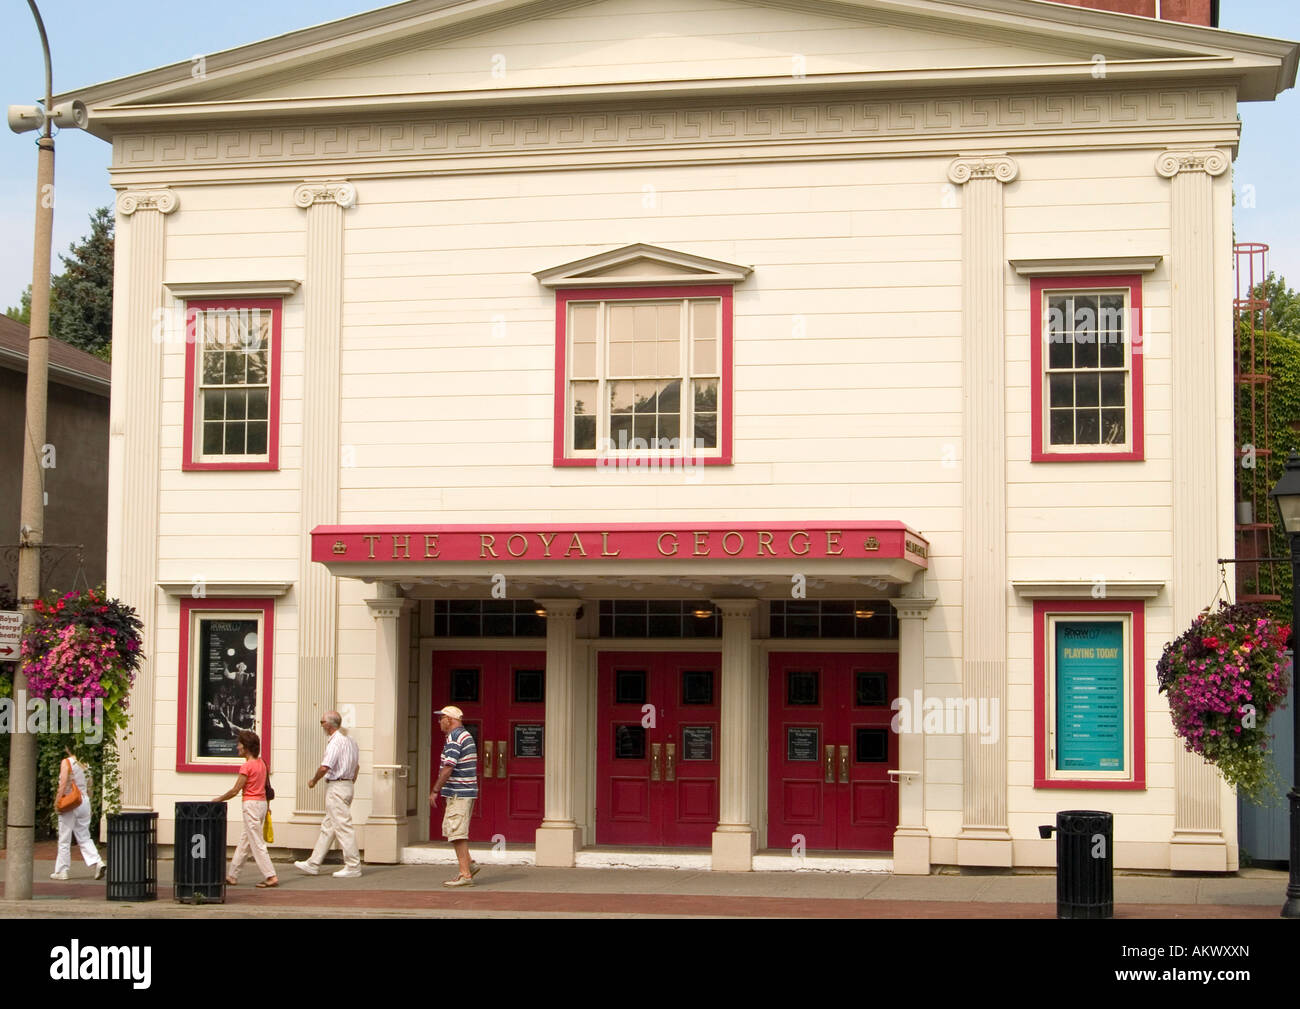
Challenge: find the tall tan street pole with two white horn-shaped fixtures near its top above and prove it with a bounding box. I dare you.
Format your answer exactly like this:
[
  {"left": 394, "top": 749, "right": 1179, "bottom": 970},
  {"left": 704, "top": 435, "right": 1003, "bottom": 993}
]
[{"left": 4, "top": 0, "right": 88, "bottom": 900}]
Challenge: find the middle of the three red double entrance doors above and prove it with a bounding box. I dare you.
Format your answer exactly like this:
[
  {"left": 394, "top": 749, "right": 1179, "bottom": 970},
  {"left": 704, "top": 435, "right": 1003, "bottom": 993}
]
[{"left": 595, "top": 653, "right": 722, "bottom": 846}]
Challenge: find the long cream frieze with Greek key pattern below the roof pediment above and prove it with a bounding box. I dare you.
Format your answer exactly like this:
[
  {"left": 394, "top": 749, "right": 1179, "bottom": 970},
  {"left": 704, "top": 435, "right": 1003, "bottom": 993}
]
[{"left": 113, "top": 86, "right": 1239, "bottom": 172}]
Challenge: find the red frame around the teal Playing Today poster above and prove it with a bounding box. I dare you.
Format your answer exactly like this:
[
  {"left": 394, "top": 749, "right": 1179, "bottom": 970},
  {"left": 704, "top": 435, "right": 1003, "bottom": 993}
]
[{"left": 1034, "top": 599, "right": 1147, "bottom": 792}]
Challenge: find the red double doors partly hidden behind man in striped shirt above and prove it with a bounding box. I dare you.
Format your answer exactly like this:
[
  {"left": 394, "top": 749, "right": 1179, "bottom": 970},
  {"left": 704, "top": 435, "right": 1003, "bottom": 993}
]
[{"left": 429, "top": 651, "right": 546, "bottom": 844}]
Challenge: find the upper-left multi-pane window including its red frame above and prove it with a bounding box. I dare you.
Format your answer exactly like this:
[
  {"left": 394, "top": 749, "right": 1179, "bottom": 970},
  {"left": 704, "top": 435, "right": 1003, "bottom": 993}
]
[{"left": 183, "top": 300, "right": 281, "bottom": 469}]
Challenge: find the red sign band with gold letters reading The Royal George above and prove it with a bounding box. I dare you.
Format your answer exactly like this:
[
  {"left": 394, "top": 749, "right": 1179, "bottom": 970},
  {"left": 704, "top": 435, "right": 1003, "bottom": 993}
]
[{"left": 312, "top": 521, "right": 930, "bottom": 568}]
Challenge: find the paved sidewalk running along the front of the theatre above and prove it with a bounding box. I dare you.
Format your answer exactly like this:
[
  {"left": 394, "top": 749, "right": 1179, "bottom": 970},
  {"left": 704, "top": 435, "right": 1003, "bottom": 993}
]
[{"left": 0, "top": 861, "right": 1287, "bottom": 918}]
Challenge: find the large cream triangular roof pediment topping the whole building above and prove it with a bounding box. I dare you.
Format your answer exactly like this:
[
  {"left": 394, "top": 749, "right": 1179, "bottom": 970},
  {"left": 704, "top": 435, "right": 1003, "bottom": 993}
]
[{"left": 61, "top": 0, "right": 1296, "bottom": 135}]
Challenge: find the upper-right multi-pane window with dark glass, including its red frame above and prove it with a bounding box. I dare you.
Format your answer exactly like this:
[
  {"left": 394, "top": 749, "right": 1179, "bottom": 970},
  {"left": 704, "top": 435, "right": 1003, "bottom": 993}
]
[{"left": 1030, "top": 276, "right": 1143, "bottom": 462}]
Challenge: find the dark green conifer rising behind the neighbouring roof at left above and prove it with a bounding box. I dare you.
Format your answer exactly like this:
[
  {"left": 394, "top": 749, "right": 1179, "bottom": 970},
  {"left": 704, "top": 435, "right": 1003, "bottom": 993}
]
[{"left": 49, "top": 207, "right": 113, "bottom": 360}]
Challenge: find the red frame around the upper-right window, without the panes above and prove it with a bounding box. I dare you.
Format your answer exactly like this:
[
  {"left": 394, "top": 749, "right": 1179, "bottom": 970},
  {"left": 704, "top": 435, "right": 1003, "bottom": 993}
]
[{"left": 1030, "top": 273, "right": 1145, "bottom": 463}]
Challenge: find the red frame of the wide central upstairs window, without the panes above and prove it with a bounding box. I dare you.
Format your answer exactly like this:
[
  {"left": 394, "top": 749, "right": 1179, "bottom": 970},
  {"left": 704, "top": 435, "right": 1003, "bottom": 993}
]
[{"left": 553, "top": 285, "right": 733, "bottom": 467}]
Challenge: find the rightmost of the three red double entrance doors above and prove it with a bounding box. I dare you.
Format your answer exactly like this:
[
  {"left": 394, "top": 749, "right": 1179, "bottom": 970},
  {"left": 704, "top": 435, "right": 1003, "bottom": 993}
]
[{"left": 767, "top": 653, "right": 898, "bottom": 852}]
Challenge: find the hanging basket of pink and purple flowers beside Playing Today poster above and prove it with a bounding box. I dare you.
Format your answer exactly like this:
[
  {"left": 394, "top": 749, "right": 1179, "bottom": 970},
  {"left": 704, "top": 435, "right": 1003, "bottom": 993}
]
[{"left": 1156, "top": 603, "right": 1291, "bottom": 802}]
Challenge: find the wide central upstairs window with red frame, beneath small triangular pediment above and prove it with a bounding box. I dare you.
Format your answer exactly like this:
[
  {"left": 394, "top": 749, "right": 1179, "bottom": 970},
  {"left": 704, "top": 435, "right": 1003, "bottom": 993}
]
[{"left": 555, "top": 287, "right": 731, "bottom": 464}]
